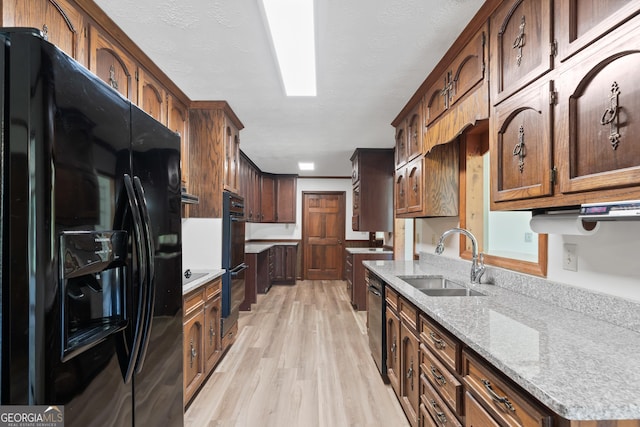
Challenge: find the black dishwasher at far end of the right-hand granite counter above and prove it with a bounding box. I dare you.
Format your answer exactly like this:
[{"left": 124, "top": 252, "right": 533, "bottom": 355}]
[{"left": 367, "top": 274, "right": 389, "bottom": 382}]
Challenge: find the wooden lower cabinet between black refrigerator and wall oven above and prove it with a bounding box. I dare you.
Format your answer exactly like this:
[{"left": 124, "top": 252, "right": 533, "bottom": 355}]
[{"left": 182, "top": 278, "right": 225, "bottom": 406}]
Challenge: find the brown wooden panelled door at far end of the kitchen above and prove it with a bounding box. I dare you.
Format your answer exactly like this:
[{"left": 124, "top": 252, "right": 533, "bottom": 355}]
[{"left": 302, "top": 191, "right": 346, "bottom": 280}]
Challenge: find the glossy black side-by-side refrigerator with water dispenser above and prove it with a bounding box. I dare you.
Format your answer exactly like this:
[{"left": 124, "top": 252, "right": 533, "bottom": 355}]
[{"left": 0, "top": 29, "right": 183, "bottom": 427}]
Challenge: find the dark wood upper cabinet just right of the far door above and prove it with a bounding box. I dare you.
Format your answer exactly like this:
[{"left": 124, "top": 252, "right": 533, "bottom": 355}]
[{"left": 351, "top": 148, "right": 393, "bottom": 232}]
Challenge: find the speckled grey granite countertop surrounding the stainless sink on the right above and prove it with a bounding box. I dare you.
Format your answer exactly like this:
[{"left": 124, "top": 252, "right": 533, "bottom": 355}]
[{"left": 364, "top": 261, "right": 640, "bottom": 420}]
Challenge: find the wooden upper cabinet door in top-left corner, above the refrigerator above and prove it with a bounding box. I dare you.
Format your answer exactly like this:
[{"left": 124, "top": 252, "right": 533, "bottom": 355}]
[{"left": 2, "top": 0, "right": 86, "bottom": 65}]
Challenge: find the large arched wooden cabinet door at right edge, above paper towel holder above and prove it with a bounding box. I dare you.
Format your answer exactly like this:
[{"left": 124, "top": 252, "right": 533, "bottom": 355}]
[{"left": 556, "top": 17, "right": 640, "bottom": 197}]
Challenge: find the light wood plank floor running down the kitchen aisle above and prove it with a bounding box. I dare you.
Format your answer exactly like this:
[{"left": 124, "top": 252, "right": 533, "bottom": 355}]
[{"left": 185, "top": 281, "right": 408, "bottom": 427}]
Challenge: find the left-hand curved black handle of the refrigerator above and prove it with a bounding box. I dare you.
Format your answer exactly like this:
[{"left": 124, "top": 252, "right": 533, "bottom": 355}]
[{"left": 123, "top": 174, "right": 148, "bottom": 384}]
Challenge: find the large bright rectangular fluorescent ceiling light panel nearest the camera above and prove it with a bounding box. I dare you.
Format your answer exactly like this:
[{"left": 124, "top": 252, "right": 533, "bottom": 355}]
[{"left": 262, "top": 0, "right": 316, "bottom": 96}]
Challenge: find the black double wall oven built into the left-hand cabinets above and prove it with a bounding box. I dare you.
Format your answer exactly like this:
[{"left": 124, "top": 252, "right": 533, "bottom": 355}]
[{"left": 222, "top": 191, "right": 247, "bottom": 336}]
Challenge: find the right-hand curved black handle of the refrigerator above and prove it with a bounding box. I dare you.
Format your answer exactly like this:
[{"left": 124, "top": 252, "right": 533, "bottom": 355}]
[{"left": 133, "top": 176, "right": 156, "bottom": 373}]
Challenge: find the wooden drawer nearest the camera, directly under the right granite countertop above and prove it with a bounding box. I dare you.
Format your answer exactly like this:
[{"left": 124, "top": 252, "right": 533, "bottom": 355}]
[{"left": 462, "top": 351, "right": 551, "bottom": 427}]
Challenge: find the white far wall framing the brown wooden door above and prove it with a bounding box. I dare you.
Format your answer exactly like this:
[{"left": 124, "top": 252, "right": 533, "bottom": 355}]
[{"left": 246, "top": 178, "right": 369, "bottom": 240}]
